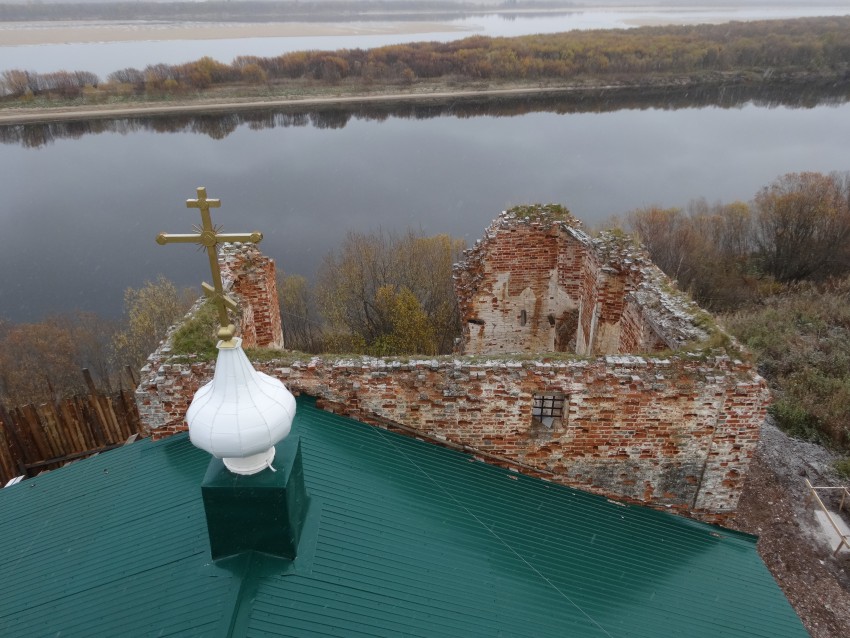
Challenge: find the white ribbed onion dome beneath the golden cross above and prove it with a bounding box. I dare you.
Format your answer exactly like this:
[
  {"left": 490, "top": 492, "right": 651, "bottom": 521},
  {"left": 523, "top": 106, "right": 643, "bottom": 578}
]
[{"left": 186, "top": 339, "right": 295, "bottom": 474}]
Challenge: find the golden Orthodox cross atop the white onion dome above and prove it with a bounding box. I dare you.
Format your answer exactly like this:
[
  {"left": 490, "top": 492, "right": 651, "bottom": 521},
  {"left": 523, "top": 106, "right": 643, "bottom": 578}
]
[{"left": 156, "top": 187, "right": 263, "bottom": 347}]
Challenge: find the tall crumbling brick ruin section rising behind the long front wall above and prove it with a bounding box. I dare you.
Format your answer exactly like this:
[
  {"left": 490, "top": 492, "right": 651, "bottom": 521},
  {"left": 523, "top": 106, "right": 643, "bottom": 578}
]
[{"left": 455, "top": 211, "right": 706, "bottom": 355}]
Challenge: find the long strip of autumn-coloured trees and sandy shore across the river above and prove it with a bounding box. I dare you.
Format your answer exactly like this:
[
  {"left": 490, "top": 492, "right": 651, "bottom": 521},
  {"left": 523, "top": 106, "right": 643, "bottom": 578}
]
[{"left": 0, "top": 16, "right": 850, "bottom": 125}]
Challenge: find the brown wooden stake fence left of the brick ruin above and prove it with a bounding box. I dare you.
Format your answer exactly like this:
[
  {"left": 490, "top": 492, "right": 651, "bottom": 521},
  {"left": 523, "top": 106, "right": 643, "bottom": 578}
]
[{"left": 0, "top": 370, "right": 142, "bottom": 487}]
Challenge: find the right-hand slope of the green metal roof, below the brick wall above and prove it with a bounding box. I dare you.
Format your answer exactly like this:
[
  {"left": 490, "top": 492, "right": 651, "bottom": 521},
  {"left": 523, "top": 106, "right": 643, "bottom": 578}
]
[{"left": 235, "top": 404, "right": 805, "bottom": 636}]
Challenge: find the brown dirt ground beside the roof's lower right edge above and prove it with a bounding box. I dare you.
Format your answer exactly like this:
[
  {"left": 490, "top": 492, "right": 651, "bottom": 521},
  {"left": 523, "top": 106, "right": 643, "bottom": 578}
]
[{"left": 733, "top": 422, "right": 850, "bottom": 638}]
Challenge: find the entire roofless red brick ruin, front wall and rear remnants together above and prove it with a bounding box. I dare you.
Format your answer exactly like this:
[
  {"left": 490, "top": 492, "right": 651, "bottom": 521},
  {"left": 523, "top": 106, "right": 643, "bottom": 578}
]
[{"left": 136, "top": 216, "right": 770, "bottom": 523}]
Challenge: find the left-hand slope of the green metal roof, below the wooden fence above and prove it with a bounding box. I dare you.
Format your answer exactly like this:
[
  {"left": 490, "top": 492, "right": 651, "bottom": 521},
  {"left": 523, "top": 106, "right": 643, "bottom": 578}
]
[{"left": 0, "top": 432, "right": 239, "bottom": 636}]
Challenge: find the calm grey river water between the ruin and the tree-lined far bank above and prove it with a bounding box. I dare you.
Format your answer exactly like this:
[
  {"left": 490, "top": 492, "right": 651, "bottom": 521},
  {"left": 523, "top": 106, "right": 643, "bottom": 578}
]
[{"left": 0, "top": 92, "right": 850, "bottom": 321}]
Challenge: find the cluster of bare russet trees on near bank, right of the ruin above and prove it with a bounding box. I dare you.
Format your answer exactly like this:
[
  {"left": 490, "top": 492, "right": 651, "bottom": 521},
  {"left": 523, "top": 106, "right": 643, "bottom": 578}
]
[{"left": 628, "top": 173, "right": 850, "bottom": 309}]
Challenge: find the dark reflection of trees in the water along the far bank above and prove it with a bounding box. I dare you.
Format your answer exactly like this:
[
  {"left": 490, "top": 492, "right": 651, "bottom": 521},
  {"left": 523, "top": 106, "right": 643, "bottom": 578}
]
[{"left": 0, "top": 83, "right": 850, "bottom": 148}]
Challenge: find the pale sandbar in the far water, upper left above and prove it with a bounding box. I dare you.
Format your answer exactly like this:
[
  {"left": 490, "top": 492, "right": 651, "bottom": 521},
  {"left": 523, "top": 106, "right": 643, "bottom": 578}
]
[{"left": 0, "top": 22, "right": 466, "bottom": 46}]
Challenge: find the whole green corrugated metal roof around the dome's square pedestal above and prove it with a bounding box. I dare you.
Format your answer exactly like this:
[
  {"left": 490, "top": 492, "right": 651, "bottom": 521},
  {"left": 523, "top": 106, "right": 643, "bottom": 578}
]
[{"left": 0, "top": 399, "right": 807, "bottom": 638}]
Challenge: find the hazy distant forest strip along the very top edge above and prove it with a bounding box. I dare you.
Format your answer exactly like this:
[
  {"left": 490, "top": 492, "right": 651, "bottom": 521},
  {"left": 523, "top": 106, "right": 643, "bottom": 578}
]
[{"left": 0, "top": 0, "right": 560, "bottom": 22}]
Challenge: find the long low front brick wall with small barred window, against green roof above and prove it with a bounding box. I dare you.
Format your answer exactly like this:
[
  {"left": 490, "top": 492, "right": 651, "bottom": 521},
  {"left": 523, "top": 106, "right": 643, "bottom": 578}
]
[{"left": 139, "top": 356, "right": 768, "bottom": 522}]
